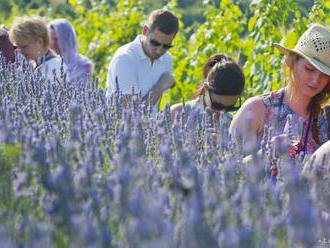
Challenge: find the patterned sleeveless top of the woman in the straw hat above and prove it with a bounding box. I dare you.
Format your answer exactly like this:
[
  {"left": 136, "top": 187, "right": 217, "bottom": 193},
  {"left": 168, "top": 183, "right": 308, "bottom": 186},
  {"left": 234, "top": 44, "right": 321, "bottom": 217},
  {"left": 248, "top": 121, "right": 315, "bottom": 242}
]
[{"left": 257, "top": 88, "right": 328, "bottom": 154}]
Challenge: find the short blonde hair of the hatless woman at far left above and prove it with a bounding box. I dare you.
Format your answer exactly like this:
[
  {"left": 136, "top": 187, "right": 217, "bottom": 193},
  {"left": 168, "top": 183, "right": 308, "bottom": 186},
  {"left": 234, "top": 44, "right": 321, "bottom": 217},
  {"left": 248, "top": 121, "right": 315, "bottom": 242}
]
[{"left": 9, "top": 16, "right": 49, "bottom": 48}]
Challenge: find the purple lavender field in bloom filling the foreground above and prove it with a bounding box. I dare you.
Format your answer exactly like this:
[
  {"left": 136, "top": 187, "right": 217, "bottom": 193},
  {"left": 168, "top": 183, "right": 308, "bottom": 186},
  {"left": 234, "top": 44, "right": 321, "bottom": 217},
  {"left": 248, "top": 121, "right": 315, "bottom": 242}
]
[{"left": 0, "top": 53, "right": 330, "bottom": 248}]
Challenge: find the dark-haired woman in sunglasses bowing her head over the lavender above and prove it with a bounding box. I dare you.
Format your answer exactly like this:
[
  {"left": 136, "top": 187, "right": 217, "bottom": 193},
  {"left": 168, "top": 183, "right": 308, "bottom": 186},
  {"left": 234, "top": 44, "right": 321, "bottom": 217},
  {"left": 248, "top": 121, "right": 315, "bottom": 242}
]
[{"left": 171, "top": 54, "right": 245, "bottom": 127}]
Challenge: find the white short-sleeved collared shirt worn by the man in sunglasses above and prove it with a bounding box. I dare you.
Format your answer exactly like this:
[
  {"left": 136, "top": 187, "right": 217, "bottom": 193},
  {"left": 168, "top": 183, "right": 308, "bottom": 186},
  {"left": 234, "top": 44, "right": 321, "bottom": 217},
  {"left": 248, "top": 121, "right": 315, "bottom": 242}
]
[{"left": 107, "top": 35, "right": 173, "bottom": 110}]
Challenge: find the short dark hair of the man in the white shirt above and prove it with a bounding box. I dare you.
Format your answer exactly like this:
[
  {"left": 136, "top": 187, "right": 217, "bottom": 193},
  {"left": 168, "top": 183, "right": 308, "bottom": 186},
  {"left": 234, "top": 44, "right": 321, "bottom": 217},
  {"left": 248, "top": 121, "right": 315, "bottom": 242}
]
[{"left": 147, "top": 9, "right": 179, "bottom": 35}]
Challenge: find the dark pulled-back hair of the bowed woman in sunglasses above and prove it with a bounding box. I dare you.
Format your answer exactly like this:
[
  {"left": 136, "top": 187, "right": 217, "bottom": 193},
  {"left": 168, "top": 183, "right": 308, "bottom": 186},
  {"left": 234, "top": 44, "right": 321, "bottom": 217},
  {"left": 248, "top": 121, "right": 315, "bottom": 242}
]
[{"left": 204, "top": 54, "right": 245, "bottom": 95}]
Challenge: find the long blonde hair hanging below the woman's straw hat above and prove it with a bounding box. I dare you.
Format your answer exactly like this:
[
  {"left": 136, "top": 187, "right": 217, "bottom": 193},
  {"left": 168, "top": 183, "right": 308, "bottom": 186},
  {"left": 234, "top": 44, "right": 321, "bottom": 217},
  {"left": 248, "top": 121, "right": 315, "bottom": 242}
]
[{"left": 282, "top": 52, "right": 330, "bottom": 144}]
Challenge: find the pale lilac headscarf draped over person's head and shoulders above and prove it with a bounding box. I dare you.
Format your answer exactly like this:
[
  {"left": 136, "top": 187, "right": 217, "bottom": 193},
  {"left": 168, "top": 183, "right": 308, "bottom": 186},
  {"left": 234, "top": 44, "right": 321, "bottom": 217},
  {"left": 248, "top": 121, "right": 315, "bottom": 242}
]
[{"left": 49, "top": 18, "right": 93, "bottom": 81}]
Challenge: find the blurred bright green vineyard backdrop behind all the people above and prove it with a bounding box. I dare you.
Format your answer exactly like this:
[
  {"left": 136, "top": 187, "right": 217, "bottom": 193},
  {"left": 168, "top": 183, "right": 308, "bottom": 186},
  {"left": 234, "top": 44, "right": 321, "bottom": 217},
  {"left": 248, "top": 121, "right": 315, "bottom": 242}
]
[{"left": 0, "top": 0, "right": 330, "bottom": 105}]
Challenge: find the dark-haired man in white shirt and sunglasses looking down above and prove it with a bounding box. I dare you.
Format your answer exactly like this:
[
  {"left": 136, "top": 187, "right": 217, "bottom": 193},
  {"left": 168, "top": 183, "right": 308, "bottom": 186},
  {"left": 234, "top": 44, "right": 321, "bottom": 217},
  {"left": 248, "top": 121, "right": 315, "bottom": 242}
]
[{"left": 107, "top": 9, "right": 179, "bottom": 110}]
